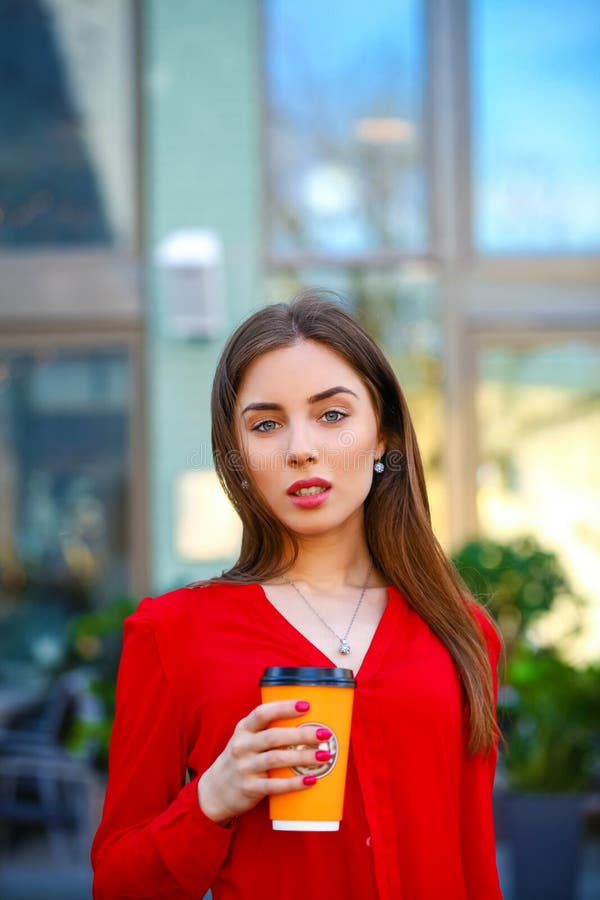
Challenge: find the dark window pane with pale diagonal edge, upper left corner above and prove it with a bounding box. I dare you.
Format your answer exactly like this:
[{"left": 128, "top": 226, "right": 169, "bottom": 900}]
[{"left": 0, "top": 0, "right": 134, "bottom": 247}]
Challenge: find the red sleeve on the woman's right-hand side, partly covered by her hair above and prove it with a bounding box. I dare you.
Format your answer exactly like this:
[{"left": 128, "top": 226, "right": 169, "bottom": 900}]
[{"left": 461, "top": 609, "right": 502, "bottom": 900}]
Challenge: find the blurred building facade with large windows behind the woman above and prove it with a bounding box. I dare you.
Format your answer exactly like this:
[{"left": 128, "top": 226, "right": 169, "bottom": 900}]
[{"left": 0, "top": 0, "right": 600, "bottom": 703}]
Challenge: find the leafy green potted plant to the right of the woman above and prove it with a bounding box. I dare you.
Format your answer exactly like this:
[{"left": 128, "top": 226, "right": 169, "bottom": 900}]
[{"left": 453, "top": 538, "right": 600, "bottom": 791}]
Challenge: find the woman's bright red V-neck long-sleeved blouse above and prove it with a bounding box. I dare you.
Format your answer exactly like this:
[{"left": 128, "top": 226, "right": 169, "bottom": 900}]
[{"left": 92, "top": 584, "right": 502, "bottom": 900}]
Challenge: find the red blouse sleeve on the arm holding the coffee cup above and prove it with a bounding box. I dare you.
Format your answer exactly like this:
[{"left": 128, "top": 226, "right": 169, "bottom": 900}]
[{"left": 92, "top": 600, "right": 234, "bottom": 900}]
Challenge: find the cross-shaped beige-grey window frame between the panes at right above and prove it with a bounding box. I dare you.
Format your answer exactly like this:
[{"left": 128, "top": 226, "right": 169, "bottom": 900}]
[{"left": 260, "top": 0, "right": 600, "bottom": 547}]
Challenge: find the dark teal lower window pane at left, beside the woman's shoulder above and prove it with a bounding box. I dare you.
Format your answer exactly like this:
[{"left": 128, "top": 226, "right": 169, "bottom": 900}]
[{"left": 0, "top": 351, "right": 132, "bottom": 668}]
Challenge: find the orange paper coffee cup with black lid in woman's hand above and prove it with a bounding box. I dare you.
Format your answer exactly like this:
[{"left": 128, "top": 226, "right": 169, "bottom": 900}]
[{"left": 260, "top": 666, "right": 356, "bottom": 831}]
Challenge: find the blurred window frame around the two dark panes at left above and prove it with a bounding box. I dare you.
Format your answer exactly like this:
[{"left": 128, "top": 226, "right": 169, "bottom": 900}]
[{"left": 0, "top": 0, "right": 145, "bottom": 596}]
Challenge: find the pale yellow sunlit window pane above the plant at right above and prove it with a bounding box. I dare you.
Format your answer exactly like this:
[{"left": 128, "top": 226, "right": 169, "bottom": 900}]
[{"left": 477, "top": 342, "right": 600, "bottom": 657}]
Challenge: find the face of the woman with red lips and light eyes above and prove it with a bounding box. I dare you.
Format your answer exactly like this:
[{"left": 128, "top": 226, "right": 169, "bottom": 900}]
[{"left": 236, "top": 340, "right": 385, "bottom": 535}]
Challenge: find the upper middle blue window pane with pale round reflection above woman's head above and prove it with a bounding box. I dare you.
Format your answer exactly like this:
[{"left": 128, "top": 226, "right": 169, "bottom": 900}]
[{"left": 265, "top": 0, "right": 428, "bottom": 256}]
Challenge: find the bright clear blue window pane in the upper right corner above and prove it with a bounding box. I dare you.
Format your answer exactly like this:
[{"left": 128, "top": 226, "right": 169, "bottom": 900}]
[{"left": 470, "top": 0, "right": 600, "bottom": 254}]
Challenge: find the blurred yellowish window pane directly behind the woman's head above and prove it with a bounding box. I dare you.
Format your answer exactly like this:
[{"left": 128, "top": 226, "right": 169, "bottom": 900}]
[{"left": 267, "top": 265, "right": 448, "bottom": 543}]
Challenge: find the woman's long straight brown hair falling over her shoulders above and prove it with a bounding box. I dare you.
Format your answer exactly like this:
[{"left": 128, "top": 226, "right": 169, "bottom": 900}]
[{"left": 199, "top": 291, "right": 498, "bottom": 753}]
